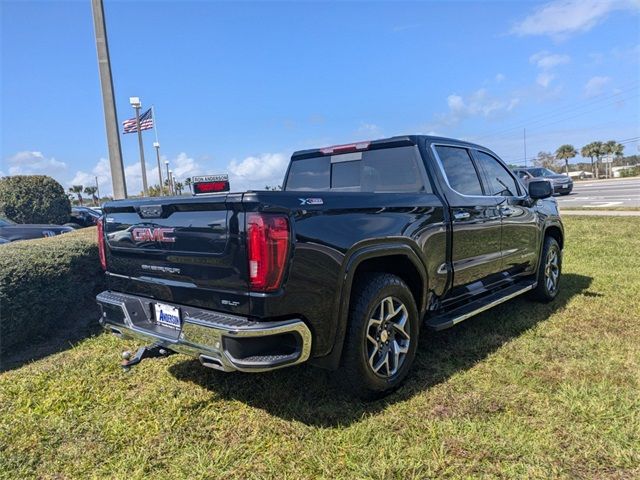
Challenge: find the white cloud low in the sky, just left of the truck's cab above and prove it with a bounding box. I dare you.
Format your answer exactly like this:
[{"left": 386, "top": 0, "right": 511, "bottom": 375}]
[{"left": 227, "top": 153, "right": 289, "bottom": 191}]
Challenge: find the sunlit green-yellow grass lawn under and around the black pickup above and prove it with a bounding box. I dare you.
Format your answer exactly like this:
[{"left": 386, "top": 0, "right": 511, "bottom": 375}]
[{"left": 0, "top": 217, "right": 640, "bottom": 479}]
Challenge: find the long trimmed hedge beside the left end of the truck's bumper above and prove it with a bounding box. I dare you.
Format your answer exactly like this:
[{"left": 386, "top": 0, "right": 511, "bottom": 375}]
[{"left": 0, "top": 227, "right": 104, "bottom": 358}]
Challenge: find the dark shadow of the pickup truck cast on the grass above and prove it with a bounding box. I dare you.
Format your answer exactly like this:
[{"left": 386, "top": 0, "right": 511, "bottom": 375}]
[{"left": 169, "top": 274, "right": 593, "bottom": 427}]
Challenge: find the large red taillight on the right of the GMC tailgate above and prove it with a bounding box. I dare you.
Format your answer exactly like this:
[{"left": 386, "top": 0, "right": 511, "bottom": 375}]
[{"left": 247, "top": 212, "right": 289, "bottom": 292}]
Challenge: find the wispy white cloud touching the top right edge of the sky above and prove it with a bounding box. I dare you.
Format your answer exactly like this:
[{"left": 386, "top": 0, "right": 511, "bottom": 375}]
[{"left": 510, "top": 0, "right": 640, "bottom": 40}]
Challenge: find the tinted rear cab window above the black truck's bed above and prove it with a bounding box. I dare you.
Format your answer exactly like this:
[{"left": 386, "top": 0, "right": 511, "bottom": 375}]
[{"left": 284, "top": 146, "right": 432, "bottom": 193}]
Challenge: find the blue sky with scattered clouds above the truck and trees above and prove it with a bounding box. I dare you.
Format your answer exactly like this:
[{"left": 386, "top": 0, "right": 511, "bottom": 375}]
[{"left": 0, "top": 0, "right": 640, "bottom": 193}]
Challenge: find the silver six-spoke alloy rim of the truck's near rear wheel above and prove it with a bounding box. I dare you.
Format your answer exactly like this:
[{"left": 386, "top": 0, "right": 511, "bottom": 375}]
[{"left": 367, "top": 297, "right": 411, "bottom": 378}]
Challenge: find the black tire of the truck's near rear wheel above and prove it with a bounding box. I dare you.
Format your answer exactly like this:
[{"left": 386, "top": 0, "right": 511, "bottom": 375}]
[{"left": 339, "top": 273, "right": 419, "bottom": 400}]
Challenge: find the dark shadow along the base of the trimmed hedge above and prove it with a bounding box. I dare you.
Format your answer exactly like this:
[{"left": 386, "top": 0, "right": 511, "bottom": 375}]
[{"left": 0, "top": 303, "right": 102, "bottom": 373}]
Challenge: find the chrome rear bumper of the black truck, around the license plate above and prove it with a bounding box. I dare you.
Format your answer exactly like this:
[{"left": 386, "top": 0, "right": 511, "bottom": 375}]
[{"left": 96, "top": 291, "right": 311, "bottom": 372}]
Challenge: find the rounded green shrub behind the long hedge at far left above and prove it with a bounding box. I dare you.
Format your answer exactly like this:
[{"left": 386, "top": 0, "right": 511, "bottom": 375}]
[{"left": 0, "top": 175, "right": 71, "bottom": 225}]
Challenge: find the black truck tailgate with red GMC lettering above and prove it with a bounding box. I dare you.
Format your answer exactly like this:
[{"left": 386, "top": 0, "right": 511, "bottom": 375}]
[{"left": 104, "top": 195, "right": 249, "bottom": 314}]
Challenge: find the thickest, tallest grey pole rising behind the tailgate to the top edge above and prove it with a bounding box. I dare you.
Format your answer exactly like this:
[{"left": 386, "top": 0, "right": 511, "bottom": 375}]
[{"left": 91, "top": 0, "right": 127, "bottom": 200}]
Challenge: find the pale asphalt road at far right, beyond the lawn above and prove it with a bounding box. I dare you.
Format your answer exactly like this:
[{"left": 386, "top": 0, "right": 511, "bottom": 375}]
[{"left": 555, "top": 177, "right": 640, "bottom": 206}]
